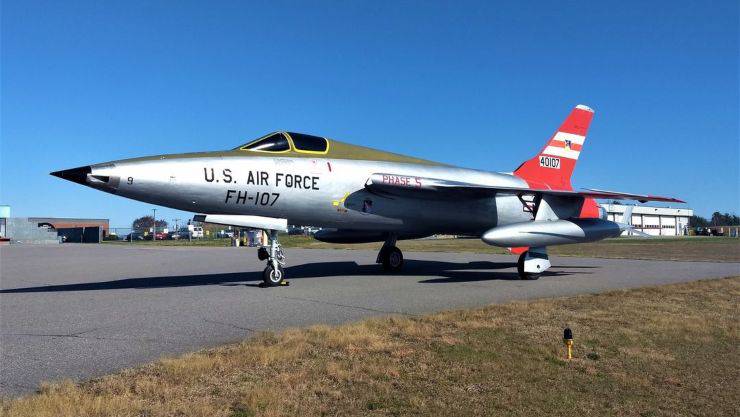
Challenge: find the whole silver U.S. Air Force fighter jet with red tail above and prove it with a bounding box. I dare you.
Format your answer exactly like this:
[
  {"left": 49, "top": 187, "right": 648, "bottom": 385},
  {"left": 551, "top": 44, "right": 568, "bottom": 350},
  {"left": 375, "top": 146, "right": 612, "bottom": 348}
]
[{"left": 51, "top": 105, "right": 683, "bottom": 286}]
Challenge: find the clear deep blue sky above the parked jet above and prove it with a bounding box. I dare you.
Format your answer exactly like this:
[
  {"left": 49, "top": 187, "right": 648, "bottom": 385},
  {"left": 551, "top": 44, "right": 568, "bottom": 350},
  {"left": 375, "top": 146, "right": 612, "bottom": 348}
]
[{"left": 0, "top": 0, "right": 740, "bottom": 226}]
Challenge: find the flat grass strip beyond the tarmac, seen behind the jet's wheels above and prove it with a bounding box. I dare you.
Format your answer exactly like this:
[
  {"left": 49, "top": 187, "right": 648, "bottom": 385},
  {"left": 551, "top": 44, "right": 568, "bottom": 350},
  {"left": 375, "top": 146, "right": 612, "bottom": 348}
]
[{"left": 111, "top": 236, "right": 740, "bottom": 262}]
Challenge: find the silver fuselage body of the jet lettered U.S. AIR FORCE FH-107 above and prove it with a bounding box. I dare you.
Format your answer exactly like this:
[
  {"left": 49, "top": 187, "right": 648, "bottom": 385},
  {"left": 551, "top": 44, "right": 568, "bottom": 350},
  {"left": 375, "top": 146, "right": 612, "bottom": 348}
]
[{"left": 87, "top": 155, "right": 531, "bottom": 236}]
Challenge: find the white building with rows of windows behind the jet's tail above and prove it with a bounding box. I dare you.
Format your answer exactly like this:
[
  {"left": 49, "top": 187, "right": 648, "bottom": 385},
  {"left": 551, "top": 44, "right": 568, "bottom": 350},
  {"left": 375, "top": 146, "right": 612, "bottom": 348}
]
[{"left": 601, "top": 203, "right": 694, "bottom": 236}]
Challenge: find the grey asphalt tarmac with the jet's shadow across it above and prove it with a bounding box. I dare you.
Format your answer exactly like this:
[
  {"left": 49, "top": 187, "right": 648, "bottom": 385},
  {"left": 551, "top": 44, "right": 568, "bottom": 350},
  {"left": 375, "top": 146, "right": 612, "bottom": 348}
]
[{"left": 0, "top": 244, "right": 740, "bottom": 396}]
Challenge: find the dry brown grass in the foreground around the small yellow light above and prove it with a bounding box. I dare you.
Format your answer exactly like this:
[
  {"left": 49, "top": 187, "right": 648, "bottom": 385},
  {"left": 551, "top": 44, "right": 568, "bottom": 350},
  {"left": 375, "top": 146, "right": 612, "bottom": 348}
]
[{"left": 0, "top": 277, "right": 740, "bottom": 417}]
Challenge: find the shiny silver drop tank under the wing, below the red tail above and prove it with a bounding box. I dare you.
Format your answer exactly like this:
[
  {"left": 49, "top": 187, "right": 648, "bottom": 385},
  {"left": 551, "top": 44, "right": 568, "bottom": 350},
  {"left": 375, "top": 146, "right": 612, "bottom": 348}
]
[{"left": 481, "top": 219, "right": 623, "bottom": 248}]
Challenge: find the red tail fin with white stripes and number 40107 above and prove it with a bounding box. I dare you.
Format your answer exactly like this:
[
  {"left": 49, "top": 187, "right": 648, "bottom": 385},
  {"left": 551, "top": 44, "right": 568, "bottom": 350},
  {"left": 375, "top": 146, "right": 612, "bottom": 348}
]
[{"left": 514, "top": 104, "right": 594, "bottom": 190}]
